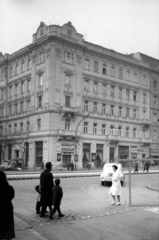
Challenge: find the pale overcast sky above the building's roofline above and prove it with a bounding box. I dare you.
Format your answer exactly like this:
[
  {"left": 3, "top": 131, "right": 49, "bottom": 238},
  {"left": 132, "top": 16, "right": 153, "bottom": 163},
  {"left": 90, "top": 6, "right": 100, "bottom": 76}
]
[{"left": 0, "top": 0, "right": 159, "bottom": 59}]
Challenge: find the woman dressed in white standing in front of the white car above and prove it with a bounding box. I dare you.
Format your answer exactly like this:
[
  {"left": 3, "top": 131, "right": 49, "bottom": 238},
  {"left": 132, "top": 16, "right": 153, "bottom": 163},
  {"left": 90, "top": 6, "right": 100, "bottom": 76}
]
[{"left": 109, "top": 164, "right": 121, "bottom": 206}]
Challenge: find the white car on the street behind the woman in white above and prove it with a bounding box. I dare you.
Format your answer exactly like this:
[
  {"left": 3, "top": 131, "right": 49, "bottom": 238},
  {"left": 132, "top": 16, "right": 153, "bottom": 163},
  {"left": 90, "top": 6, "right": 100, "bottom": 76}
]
[{"left": 100, "top": 163, "right": 125, "bottom": 186}]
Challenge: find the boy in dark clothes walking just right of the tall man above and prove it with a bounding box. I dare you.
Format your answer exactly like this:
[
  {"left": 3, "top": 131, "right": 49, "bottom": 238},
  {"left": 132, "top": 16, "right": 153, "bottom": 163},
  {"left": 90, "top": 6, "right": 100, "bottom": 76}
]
[{"left": 49, "top": 178, "right": 64, "bottom": 219}]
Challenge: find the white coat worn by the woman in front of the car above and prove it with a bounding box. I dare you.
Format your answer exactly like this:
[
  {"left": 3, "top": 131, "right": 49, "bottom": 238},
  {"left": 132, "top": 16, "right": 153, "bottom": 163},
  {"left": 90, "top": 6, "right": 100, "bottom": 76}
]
[{"left": 109, "top": 164, "right": 121, "bottom": 196}]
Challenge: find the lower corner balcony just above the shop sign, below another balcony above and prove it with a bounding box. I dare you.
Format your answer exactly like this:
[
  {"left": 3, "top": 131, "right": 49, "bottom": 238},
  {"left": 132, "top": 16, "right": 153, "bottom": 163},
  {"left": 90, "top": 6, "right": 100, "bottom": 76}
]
[{"left": 58, "top": 129, "right": 81, "bottom": 140}]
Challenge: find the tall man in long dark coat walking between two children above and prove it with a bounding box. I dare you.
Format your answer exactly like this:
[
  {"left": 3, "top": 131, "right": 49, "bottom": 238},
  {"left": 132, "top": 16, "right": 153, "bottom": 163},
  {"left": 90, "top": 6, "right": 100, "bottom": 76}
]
[{"left": 40, "top": 162, "right": 54, "bottom": 217}]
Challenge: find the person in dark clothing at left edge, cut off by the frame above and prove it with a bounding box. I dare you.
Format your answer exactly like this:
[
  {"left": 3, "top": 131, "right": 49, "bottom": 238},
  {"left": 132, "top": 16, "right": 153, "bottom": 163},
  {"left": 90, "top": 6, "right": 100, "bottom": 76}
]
[{"left": 0, "top": 171, "right": 15, "bottom": 240}]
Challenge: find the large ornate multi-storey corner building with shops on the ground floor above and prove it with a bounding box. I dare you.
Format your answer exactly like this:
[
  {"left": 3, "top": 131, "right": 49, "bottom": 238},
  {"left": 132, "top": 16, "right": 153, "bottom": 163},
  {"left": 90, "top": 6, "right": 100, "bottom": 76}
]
[{"left": 0, "top": 22, "right": 158, "bottom": 168}]
